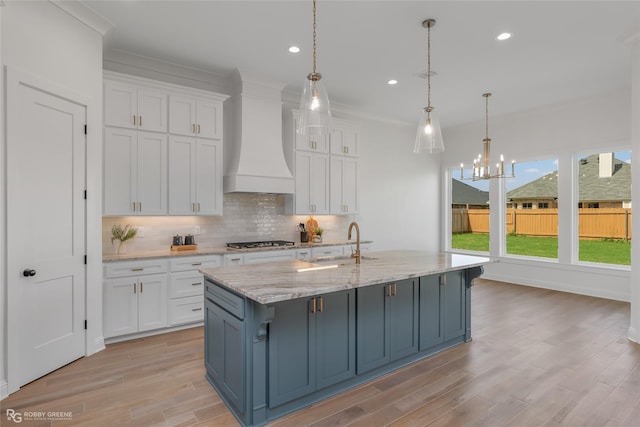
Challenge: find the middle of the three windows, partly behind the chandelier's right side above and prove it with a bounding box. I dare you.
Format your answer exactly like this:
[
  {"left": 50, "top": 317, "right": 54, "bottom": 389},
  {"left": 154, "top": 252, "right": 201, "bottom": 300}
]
[{"left": 505, "top": 159, "right": 558, "bottom": 259}]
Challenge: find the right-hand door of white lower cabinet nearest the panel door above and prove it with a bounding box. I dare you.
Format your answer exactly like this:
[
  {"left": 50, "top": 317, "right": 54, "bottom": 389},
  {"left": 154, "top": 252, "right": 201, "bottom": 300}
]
[{"left": 138, "top": 274, "right": 167, "bottom": 332}]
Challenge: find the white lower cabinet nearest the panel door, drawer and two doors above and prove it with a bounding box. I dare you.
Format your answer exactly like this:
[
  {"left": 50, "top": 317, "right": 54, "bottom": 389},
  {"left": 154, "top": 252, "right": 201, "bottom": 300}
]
[{"left": 104, "top": 260, "right": 167, "bottom": 338}]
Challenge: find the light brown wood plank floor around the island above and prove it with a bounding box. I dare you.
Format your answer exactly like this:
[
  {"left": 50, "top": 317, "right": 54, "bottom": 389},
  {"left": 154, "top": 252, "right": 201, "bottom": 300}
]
[{"left": 0, "top": 280, "right": 640, "bottom": 427}]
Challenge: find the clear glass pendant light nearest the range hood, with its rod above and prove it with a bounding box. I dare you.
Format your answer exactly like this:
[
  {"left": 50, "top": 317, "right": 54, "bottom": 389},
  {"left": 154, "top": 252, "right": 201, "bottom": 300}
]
[{"left": 296, "top": 0, "right": 333, "bottom": 136}]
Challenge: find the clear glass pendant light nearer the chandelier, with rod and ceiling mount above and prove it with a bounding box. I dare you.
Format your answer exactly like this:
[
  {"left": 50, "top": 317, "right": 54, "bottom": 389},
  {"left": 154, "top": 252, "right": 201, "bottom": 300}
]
[{"left": 413, "top": 19, "right": 444, "bottom": 153}]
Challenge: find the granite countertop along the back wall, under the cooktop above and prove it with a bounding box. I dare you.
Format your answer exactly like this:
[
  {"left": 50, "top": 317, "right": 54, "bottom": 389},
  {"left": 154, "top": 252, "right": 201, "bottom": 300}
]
[{"left": 102, "top": 240, "right": 372, "bottom": 262}]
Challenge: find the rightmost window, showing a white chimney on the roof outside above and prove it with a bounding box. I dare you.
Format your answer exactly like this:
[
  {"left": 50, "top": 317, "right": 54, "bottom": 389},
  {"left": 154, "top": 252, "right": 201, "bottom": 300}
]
[{"left": 576, "top": 151, "right": 631, "bottom": 265}]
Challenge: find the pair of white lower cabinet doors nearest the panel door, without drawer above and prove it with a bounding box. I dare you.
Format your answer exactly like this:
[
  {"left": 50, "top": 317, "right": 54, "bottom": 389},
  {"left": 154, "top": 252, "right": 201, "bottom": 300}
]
[{"left": 104, "top": 274, "right": 167, "bottom": 338}]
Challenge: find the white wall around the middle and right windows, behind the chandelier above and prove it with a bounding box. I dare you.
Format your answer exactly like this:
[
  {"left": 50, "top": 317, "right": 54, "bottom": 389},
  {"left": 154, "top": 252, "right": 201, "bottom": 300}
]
[{"left": 444, "top": 88, "right": 640, "bottom": 301}]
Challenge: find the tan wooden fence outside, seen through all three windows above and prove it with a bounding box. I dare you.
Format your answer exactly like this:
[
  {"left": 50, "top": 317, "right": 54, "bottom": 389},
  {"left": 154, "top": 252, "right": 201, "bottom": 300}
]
[{"left": 451, "top": 208, "right": 631, "bottom": 240}]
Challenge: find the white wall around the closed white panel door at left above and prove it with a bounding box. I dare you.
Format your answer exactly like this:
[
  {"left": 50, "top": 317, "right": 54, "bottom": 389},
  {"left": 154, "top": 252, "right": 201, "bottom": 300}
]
[{"left": 0, "top": 1, "right": 103, "bottom": 397}]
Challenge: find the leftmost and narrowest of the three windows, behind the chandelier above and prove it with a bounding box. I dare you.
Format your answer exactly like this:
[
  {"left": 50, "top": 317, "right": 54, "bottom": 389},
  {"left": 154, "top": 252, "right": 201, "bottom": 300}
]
[{"left": 451, "top": 169, "right": 490, "bottom": 252}]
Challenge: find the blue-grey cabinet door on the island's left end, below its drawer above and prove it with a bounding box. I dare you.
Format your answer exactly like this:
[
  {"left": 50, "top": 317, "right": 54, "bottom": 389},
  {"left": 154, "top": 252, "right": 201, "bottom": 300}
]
[{"left": 205, "top": 299, "right": 246, "bottom": 413}]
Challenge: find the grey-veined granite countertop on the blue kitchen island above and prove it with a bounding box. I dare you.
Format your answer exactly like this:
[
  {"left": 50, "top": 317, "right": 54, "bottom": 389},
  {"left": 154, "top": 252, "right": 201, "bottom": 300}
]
[{"left": 200, "top": 251, "right": 492, "bottom": 304}]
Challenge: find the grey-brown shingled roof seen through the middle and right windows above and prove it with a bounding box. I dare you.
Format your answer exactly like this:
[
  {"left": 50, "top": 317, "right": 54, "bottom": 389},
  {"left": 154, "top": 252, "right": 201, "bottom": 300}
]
[{"left": 507, "top": 154, "right": 631, "bottom": 201}]
